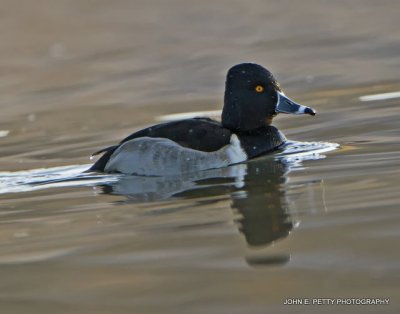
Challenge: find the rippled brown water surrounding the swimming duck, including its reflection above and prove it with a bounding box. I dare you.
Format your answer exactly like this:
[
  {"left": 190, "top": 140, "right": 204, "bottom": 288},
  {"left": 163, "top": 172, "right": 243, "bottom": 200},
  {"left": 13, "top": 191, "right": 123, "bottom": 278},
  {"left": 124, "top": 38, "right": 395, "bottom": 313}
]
[{"left": 0, "top": 0, "right": 400, "bottom": 314}]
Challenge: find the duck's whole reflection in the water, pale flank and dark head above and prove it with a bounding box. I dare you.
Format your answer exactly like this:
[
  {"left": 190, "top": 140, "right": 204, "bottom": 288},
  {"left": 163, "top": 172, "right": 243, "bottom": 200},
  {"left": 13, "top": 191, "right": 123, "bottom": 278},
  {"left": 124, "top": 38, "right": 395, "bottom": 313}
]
[{"left": 102, "top": 156, "right": 304, "bottom": 251}]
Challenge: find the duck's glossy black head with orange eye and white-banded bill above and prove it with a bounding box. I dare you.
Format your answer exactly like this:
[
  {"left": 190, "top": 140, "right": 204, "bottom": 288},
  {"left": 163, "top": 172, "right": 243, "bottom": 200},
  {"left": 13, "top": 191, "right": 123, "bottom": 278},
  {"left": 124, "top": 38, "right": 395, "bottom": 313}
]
[{"left": 222, "top": 63, "right": 315, "bottom": 132}]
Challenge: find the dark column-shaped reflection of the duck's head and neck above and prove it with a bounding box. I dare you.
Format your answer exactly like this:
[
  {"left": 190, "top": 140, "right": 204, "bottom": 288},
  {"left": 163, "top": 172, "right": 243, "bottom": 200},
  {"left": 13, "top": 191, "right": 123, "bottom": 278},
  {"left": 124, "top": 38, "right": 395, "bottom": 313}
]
[{"left": 232, "top": 159, "right": 293, "bottom": 246}]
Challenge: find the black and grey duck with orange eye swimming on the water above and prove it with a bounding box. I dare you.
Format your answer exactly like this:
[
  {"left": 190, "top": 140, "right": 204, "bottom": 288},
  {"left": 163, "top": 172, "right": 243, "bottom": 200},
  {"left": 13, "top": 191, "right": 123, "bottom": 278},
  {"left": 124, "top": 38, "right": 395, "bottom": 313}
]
[{"left": 87, "top": 63, "right": 316, "bottom": 176}]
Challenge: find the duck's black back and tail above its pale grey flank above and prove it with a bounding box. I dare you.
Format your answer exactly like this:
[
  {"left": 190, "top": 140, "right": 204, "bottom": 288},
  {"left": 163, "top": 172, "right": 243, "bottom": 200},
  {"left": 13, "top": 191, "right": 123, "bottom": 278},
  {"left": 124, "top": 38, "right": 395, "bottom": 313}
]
[{"left": 88, "top": 118, "right": 232, "bottom": 171}]
